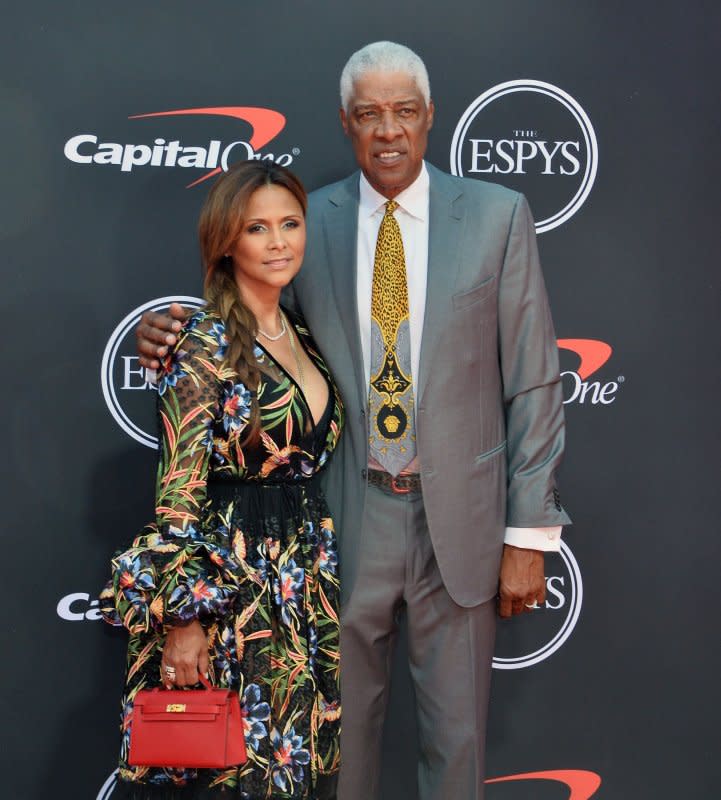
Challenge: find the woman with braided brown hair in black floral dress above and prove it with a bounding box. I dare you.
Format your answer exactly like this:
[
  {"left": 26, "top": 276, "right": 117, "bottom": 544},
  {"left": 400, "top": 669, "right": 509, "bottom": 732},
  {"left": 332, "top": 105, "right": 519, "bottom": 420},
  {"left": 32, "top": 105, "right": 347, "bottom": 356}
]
[{"left": 101, "top": 161, "right": 343, "bottom": 800}]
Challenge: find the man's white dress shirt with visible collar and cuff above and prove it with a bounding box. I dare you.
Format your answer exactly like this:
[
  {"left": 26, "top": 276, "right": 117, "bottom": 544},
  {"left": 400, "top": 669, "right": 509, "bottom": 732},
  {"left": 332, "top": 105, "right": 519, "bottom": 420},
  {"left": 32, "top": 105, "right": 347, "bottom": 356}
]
[{"left": 356, "top": 163, "right": 561, "bottom": 551}]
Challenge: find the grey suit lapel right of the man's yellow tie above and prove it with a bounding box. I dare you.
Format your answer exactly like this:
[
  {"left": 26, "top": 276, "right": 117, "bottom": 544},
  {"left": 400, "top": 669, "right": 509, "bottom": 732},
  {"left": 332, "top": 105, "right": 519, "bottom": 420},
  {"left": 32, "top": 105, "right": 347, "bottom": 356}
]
[{"left": 417, "top": 164, "right": 466, "bottom": 403}]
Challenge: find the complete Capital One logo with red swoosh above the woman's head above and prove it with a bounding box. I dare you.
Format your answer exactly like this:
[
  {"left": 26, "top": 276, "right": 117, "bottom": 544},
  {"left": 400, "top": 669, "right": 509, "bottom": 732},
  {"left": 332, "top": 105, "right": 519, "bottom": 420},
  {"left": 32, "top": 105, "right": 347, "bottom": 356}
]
[{"left": 63, "top": 106, "right": 300, "bottom": 188}]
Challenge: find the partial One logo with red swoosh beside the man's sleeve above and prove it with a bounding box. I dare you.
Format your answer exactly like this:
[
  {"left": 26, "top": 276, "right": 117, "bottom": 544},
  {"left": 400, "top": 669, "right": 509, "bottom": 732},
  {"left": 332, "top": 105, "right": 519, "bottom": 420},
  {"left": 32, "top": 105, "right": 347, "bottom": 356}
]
[{"left": 558, "top": 339, "right": 626, "bottom": 406}]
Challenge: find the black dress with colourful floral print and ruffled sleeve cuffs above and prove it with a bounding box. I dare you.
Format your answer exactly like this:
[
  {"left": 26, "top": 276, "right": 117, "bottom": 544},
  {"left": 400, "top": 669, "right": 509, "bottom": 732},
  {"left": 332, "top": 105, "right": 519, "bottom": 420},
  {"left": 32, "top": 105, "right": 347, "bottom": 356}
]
[{"left": 101, "top": 310, "right": 343, "bottom": 800}]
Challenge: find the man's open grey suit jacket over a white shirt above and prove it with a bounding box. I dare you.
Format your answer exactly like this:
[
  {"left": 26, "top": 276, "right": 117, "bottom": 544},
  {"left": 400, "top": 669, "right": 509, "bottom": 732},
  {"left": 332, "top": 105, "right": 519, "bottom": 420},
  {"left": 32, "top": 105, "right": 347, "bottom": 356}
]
[{"left": 286, "top": 165, "right": 570, "bottom": 606}]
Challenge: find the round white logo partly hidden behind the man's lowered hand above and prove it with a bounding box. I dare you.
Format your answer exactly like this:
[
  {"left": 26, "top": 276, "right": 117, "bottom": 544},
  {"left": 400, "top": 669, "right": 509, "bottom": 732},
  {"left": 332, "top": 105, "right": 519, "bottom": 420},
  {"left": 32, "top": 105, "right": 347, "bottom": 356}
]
[{"left": 493, "top": 541, "right": 583, "bottom": 669}]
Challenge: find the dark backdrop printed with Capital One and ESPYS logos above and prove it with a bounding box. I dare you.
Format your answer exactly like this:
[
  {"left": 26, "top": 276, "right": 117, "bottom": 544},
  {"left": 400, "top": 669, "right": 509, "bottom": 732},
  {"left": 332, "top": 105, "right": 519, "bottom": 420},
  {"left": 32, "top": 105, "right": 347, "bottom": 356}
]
[{"left": 0, "top": 0, "right": 721, "bottom": 800}]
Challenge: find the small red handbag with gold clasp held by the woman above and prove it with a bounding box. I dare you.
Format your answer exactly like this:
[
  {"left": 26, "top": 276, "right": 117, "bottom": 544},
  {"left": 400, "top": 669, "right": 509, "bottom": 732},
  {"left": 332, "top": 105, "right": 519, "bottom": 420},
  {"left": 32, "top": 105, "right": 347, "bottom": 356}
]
[{"left": 128, "top": 676, "right": 247, "bottom": 768}]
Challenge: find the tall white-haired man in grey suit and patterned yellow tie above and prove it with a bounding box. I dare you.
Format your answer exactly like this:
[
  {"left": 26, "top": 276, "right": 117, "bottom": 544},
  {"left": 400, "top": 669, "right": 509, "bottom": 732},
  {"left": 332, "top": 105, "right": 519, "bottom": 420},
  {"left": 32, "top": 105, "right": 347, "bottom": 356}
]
[{"left": 139, "top": 42, "right": 569, "bottom": 800}]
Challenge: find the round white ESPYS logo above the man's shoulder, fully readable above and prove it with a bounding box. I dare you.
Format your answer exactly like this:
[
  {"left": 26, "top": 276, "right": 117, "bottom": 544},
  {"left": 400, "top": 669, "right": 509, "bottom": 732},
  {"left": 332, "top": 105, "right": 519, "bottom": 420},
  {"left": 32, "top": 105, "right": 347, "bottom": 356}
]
[{"left": 451, "top": 79, "right": 598, "bottom": 233}]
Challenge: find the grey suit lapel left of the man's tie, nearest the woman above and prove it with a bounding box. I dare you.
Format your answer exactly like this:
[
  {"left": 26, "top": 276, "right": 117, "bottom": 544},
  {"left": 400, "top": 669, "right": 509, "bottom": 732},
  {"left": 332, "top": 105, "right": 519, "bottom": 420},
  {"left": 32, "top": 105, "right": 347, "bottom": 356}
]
[{"left": 323, "top": 172, "right": 367, "bottom": 402}]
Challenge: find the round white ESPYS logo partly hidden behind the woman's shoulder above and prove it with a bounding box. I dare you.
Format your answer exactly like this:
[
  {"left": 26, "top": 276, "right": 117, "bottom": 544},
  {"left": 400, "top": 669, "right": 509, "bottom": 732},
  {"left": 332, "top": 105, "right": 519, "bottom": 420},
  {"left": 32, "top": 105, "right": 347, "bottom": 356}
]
[{"left": 100, "top": 296, "right": 205, "bottom": 448}]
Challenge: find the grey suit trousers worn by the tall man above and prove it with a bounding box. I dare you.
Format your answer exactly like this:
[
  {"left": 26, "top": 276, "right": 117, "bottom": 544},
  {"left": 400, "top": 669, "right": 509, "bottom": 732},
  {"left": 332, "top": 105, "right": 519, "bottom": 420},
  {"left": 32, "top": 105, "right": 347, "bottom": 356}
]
[{"left": 338, "top": 486, "right": 496, "bottom": 800}]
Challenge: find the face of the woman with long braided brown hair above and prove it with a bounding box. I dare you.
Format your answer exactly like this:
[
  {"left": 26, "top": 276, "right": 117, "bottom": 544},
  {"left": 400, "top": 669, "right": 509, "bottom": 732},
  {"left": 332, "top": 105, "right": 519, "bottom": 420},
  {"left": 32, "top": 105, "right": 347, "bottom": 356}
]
[{"left": 230, "top": 184, "right": 305, "bottom": 294}]
